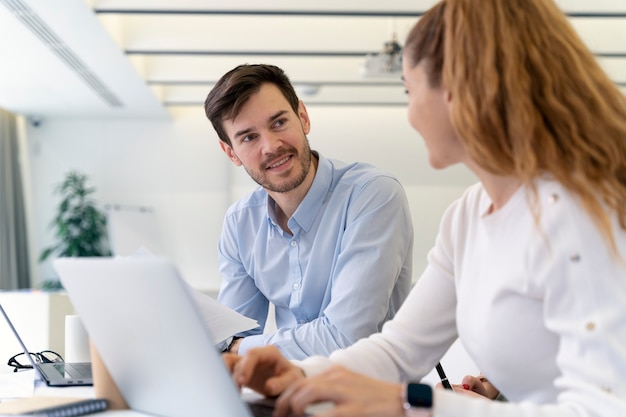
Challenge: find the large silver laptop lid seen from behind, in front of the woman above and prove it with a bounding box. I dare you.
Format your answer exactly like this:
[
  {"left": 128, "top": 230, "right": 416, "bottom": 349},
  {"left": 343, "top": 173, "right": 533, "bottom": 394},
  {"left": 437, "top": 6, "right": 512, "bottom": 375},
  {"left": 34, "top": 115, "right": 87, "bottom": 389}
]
[{"left": 54, "top": 257, "right": 314, "bottom": 417}]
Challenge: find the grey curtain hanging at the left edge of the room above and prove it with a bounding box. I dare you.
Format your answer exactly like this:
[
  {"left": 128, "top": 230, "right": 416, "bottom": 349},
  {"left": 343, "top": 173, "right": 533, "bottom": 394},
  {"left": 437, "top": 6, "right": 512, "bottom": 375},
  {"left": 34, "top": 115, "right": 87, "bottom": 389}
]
[{"left": 0, "top": 109, "right": 31, "bottom": 290}]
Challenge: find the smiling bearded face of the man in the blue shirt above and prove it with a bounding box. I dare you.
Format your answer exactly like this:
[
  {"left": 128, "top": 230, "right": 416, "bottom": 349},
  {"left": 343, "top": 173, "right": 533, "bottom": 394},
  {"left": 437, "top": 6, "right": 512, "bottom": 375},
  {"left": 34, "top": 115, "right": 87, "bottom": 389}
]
[{"left": 220, "top": 84, "right": 311, "bottom": 193}]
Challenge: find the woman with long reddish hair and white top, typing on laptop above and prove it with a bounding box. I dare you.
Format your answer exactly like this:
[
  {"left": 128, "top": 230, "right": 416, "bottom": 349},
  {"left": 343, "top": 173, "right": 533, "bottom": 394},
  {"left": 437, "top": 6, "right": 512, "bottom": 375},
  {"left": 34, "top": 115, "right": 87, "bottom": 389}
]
[{"left": 225, "top": 0, "right": 626, "bottom": 417}]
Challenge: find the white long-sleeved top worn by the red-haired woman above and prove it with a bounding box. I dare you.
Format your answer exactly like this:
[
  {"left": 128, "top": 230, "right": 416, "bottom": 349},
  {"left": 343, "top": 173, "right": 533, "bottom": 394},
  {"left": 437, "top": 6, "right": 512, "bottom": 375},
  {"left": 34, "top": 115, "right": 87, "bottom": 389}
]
[{"left": 300, "top": 180, "right": 626, "bottom": 417}]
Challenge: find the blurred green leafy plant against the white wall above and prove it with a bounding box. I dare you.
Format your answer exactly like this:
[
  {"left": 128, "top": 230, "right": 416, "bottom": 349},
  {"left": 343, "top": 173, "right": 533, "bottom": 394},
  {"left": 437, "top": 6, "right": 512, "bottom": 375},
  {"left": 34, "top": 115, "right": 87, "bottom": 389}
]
[{"left": 39, "top": 171, "right": 110, "bottom": 289}]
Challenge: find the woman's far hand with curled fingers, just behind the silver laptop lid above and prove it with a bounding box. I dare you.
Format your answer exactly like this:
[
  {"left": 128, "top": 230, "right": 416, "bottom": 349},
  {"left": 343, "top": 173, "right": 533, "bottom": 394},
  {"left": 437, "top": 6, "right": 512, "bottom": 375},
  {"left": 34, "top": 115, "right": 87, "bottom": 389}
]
[{"left": 232, "top": 346, "right": 305, "bottom": 397}]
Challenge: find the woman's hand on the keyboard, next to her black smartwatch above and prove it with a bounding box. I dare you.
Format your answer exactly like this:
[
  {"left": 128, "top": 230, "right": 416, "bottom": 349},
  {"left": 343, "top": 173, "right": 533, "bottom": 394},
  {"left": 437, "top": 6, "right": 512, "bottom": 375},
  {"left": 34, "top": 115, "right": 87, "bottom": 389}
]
[{"left": 274, "top": 366, "right": 404, "bottom": 417}]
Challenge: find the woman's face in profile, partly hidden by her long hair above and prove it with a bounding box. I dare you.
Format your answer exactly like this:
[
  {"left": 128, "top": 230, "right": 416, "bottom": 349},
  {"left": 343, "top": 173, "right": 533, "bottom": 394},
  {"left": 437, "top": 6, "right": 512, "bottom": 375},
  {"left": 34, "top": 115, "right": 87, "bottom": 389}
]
[{"left": 402, "top": 57, "right": 466, "bottom": 169}]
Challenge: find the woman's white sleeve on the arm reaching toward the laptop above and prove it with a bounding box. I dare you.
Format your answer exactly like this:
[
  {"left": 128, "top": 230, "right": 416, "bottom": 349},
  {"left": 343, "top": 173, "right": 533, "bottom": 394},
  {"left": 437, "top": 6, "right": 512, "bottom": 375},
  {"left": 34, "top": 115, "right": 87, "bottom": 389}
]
[{"left": 300, "top": 197, "right": 457, "bottom": 382}]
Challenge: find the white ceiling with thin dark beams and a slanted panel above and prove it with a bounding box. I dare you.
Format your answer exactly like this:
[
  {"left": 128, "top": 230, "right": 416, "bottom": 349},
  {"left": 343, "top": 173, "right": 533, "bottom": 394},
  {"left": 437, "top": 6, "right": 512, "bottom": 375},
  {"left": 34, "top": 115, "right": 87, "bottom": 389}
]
[{"left": 0, "top": 0, "right": 626, "bottom": 117}]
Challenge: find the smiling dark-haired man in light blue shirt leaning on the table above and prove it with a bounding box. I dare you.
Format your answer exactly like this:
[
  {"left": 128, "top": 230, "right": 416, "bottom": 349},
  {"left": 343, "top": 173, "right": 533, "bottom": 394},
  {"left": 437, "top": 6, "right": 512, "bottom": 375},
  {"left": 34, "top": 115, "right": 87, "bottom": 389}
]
[{"left": 205, "top": 65, "right": 413, "bottom": 359}]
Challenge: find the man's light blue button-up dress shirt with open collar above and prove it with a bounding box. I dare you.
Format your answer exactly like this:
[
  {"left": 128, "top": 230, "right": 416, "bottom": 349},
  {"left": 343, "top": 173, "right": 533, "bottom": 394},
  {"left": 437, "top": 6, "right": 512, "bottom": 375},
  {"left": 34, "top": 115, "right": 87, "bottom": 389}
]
[{"left": 218, "top": 153, "right": 413, "bottom": 359}]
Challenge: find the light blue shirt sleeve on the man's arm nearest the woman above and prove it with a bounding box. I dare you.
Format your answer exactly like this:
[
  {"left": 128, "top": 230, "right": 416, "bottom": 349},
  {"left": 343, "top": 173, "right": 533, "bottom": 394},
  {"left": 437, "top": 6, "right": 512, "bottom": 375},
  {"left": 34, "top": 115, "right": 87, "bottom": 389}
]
[{"left": 240, "top": 176, "right": 413, "bottom": 359}]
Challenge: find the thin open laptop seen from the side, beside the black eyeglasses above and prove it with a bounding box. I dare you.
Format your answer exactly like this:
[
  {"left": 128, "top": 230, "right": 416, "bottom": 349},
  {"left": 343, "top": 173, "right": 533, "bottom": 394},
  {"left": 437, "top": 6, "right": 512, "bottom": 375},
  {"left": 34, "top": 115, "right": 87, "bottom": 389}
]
[{"left": 0, "top": 304, "right": 93, "bottom": 387}]
